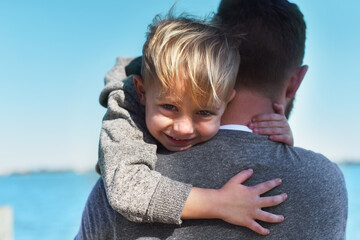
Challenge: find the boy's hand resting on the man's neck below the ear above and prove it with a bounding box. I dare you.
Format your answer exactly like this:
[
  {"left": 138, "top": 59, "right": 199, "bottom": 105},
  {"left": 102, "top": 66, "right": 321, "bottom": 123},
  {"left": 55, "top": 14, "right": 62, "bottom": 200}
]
[{"left": 248, "top": 103, "right": 294, "bottom": 146}]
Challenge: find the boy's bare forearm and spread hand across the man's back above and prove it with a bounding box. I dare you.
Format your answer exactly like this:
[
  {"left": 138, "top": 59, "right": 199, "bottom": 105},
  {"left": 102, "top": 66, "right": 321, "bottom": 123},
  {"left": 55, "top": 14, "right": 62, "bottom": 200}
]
[{"left": 182, "top": 169, "right": 287, "bottom": 235}]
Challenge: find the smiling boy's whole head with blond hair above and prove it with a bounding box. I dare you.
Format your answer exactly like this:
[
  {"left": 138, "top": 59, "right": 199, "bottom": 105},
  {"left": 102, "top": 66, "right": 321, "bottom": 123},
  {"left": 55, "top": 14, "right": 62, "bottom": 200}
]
[{"left": 134, "top": 17, "right": 240, "bottom": 151}]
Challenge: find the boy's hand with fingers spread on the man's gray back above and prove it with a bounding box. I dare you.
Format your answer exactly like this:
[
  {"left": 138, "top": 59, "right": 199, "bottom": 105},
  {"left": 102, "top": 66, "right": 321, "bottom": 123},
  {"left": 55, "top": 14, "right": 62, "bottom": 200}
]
[{"left": 217, "top": 169, "right": 287, "bottom": 235}]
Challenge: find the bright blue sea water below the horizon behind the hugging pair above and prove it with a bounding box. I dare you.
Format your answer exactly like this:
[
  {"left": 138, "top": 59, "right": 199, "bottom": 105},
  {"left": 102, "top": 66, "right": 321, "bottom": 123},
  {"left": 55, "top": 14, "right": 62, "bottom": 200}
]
[{"left": 0, "top": 165, "right": 360, "bottom": 240}]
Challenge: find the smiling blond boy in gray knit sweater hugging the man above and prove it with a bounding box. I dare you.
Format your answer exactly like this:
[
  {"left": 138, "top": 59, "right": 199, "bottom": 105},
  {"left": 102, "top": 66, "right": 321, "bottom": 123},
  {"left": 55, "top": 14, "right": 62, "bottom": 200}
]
[{"left": 99, "top": 15, "right": 288, "bottom": 234}]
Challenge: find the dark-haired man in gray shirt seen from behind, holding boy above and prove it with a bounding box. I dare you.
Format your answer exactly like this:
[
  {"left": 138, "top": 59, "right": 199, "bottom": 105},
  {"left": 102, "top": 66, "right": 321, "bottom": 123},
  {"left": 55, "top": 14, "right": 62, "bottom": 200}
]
[{"left": 79, "top": 0, "right": 347, "bottom": 239}]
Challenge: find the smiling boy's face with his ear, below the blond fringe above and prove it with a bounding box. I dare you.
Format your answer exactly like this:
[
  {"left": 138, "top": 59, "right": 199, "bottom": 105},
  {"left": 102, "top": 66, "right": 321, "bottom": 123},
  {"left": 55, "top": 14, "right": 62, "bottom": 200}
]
[{"left": 134, "top": 78, "right": 226, "bottom": 151}]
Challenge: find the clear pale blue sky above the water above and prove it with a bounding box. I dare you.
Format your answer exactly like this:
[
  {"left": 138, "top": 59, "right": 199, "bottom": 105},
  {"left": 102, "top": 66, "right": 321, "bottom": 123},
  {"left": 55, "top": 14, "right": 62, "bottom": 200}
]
[{"left": 0, "top": 0, "right": 360, "bottom": 172}]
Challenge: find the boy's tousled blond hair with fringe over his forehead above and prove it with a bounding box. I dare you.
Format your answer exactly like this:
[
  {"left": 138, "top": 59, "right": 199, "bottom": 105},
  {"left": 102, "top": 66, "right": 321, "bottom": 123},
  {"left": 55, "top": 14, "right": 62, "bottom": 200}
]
[{"left": 141, "top": 16, "right": 240, "bottom": 103}]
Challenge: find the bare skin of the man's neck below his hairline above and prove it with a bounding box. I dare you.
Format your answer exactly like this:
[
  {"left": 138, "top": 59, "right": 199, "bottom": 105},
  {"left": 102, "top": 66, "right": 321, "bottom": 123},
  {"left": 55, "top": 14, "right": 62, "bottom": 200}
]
[{"left": 221, "top": 90, "right": 274, "bottom": 126}]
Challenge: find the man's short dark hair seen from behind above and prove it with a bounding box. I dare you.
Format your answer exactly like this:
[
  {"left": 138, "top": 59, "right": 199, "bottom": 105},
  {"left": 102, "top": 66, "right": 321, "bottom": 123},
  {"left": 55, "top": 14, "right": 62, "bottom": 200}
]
[{"left": 214, "top": 0, "right": 306, "bottom": 99}]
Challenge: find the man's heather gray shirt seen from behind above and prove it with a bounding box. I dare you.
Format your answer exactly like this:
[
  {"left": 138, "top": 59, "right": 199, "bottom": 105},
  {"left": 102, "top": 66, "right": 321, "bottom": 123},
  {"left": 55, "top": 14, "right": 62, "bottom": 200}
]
[{"left": 77, "top": 130, "right": 347, "bottom": 240}]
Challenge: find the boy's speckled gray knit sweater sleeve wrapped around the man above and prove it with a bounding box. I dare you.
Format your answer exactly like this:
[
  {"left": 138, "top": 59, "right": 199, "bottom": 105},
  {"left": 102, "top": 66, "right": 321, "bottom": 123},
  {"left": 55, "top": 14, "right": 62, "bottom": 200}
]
[{"left": 95, "top": 59, "right": 191, "bottom": 224}]
